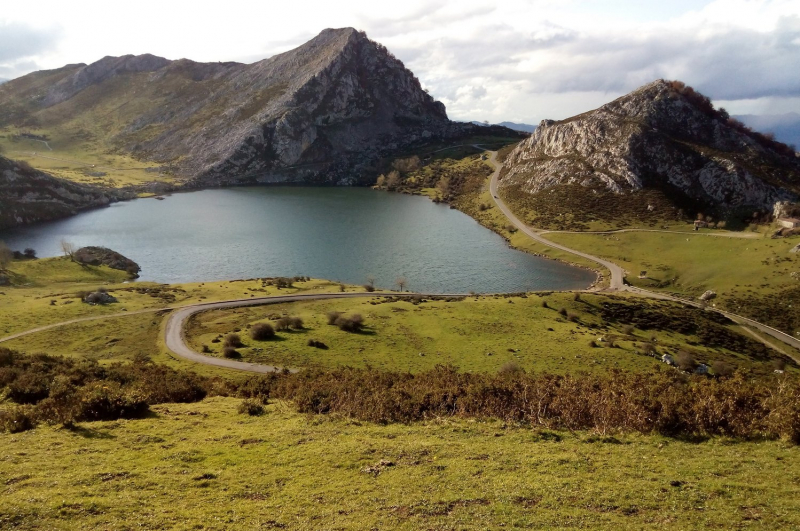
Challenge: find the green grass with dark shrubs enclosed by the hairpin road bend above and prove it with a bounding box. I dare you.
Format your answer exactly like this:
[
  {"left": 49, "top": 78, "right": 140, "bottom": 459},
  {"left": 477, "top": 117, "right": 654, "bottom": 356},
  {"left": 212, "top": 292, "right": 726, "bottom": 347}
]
[{"left": 187, "top": 293, "right": 800, "bottom": 375}]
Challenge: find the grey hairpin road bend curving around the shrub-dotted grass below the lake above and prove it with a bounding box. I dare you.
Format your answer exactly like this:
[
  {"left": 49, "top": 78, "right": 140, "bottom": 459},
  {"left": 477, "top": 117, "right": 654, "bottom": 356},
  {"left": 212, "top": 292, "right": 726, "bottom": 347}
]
[{"left": 164, "top": 292, "right": 465, "bottom": 374}]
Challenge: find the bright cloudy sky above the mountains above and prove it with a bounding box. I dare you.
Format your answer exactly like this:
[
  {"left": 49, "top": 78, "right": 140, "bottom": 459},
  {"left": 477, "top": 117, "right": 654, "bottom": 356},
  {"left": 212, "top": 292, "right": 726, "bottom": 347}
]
[{"left": 0, "top": 0, "right": 800, "bottom": 124}]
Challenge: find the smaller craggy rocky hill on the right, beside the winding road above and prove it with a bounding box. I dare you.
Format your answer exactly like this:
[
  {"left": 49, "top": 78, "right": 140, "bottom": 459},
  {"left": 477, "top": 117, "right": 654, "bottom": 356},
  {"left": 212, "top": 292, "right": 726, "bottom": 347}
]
[{"left": 501, "top": 80, "right": 800, "bottom": 212}]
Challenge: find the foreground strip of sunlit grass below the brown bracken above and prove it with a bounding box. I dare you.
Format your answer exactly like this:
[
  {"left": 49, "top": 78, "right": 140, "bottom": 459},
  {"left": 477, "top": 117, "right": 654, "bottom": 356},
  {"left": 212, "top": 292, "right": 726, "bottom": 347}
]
[{"left": 0, "top": 398, "right": 800, "bottom": 530}]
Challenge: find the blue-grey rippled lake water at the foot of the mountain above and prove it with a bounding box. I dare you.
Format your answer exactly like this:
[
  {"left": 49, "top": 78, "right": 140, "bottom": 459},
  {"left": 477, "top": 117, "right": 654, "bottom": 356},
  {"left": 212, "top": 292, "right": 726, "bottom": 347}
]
[{"left": 0, "top": 187, "right": 594, "bottom": 293}]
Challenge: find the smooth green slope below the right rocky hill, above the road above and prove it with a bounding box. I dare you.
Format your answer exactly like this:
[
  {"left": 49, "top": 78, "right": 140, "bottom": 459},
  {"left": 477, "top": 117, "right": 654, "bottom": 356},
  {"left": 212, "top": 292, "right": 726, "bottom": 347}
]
[{"left": 547, "top": 232, "right": 800, "bottom": 334}]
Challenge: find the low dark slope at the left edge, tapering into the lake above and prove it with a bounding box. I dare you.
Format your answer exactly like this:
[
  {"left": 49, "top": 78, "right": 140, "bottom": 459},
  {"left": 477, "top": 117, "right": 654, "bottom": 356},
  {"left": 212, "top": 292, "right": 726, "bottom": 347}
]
[{"left": 0, "top": 157, "right": 126, "bottom": 230}]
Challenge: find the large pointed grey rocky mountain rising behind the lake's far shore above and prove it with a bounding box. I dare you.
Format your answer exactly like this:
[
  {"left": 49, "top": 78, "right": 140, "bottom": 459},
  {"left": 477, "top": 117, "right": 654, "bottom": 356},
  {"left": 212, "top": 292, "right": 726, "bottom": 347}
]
[{"left": 0, "top": 28, "right": 490, "bottom": 187}]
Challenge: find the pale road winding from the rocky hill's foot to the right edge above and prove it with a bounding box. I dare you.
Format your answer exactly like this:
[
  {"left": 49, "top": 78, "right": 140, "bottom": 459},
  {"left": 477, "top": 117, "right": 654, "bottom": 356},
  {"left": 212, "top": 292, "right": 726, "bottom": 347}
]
[{"left": 482, "top": 151, "right": 800, "bottom": 363}]
